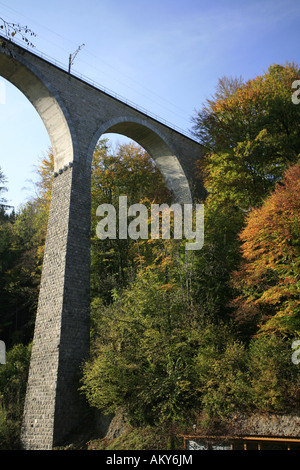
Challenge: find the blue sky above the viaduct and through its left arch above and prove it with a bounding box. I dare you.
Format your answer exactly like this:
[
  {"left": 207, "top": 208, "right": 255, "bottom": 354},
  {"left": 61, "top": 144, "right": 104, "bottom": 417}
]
[{"left": 0, "top": 0, "right": 300, "bottom": 207}]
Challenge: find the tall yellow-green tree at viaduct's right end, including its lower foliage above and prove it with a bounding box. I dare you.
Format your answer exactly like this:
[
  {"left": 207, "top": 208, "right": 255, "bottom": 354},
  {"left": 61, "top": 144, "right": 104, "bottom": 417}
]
[{"left": 190, "top": 64, "right": 300, "bottom": 318}]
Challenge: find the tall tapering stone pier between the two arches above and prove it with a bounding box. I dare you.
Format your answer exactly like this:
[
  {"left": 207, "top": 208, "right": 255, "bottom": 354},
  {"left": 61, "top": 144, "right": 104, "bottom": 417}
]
[{"left": 22, "top": 162, "right": 90, "bottom": 449}]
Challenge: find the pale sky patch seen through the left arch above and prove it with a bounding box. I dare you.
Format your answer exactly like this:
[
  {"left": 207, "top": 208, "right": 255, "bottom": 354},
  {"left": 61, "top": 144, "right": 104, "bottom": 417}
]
[{"left": 0, "top": 77, "right": 51, "bottom": 213}]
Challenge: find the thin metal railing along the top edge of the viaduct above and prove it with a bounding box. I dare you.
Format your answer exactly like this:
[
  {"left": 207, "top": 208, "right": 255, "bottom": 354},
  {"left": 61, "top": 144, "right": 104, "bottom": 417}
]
[{"left": 0, "top": 34, "right": 197, "bottom": 142}]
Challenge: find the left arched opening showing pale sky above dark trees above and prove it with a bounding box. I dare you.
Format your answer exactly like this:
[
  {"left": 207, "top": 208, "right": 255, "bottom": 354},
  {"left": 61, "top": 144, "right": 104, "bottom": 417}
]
[{"left": 0, "top": 76, "right": 51, "bottom": 349}]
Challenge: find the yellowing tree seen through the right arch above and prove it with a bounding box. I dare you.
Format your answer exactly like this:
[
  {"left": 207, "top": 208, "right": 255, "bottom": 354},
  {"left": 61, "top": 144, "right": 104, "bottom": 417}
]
[{"left": 91, "top": 139, "right": 171, "bottom": 302}]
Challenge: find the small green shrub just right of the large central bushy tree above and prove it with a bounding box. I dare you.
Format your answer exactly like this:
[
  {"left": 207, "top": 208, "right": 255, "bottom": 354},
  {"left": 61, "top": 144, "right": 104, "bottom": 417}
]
[{"left": 193, "top": 322, "right": 250, "bottom": 419}]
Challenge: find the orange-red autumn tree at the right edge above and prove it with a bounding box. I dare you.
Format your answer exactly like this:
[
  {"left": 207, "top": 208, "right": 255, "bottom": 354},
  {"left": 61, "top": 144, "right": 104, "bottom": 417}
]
[{"left": 232, "top": 163, "right": 300, "bottom": 336}]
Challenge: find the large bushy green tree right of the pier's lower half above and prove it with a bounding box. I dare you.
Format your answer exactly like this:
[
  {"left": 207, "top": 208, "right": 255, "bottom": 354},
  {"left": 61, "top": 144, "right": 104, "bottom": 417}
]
[{"left": 81, "top": 266, "right": 202, "bottom": 424}]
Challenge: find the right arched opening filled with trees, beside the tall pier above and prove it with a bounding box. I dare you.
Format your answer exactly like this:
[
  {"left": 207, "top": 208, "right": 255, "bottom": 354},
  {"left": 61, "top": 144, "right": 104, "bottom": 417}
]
[{"left": 91, "top": 133, "right": 178, "bottom": 302}]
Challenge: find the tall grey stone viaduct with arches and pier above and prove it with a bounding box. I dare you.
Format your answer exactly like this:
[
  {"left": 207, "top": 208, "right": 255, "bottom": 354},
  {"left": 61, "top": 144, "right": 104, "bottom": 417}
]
[{"left": 0, "top": 36, "right": 204, "bottom": 450}]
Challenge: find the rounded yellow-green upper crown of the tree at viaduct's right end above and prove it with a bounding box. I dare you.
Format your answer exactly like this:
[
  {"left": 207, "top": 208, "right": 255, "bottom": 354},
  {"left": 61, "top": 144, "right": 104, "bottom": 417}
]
[{"left": 194, "top": 64, "right": 300, "bottom": 211}]
